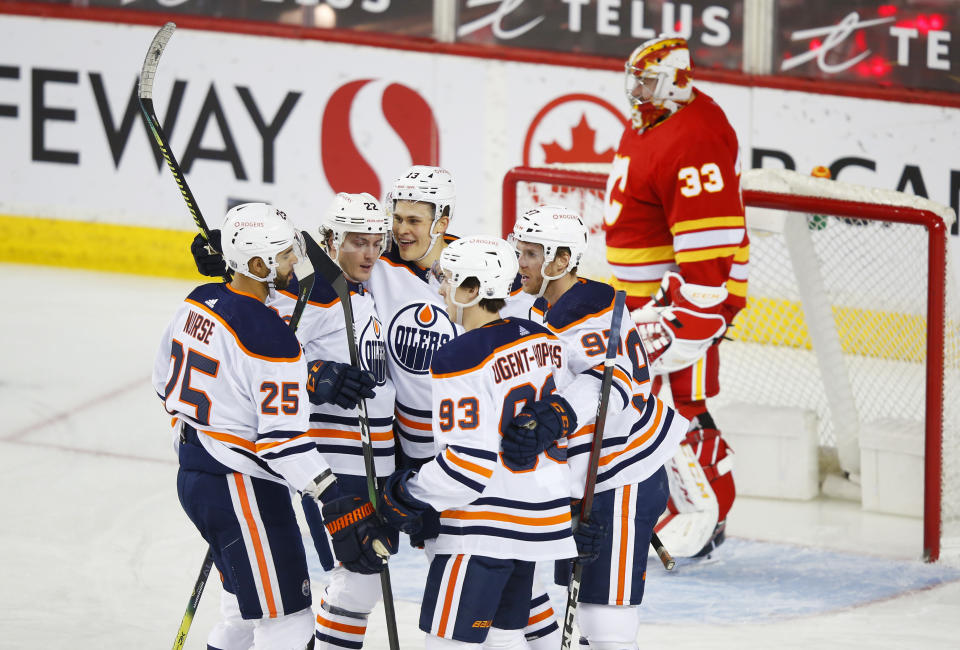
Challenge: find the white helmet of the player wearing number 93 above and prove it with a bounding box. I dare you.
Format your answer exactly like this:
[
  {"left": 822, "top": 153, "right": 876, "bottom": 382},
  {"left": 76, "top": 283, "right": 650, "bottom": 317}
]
[{"left": 439, "top": 235, "right": 518, "bottom": 325}]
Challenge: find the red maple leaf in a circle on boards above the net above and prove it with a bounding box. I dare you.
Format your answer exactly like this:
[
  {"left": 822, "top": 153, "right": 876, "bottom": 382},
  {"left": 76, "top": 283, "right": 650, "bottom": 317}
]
[{"left": 523, "top": 93, "right": 627, "bottom": 165}]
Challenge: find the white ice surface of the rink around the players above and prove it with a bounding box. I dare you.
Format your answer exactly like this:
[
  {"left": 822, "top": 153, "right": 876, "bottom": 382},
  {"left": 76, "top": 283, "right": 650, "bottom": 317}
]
[{"left": 0, "top": 265, "right": 960, "bottom": 650}]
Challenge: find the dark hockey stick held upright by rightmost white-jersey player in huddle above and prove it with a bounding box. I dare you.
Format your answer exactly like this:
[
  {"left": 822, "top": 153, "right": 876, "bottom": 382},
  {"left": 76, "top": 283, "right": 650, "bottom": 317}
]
[{"left": 560, "top": 291, "right": 627, "bottom": 650}]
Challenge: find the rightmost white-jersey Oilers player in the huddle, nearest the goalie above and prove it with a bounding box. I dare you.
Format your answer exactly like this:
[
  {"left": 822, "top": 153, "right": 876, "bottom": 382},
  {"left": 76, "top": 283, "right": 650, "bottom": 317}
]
[{"left": 503, "top": 206, "right": 687, "bottom": 650}]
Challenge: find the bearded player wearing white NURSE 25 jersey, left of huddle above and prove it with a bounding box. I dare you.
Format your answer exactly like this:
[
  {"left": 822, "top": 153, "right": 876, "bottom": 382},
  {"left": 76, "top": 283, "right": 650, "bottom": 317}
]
[{"left": 159, "top": 203, "right": 386, "bottom": 650}]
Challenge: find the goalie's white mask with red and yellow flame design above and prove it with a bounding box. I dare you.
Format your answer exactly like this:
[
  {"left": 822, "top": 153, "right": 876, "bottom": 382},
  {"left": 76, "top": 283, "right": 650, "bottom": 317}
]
[{"left": 625, "top": 36, "right": 693, "bottom": 130}]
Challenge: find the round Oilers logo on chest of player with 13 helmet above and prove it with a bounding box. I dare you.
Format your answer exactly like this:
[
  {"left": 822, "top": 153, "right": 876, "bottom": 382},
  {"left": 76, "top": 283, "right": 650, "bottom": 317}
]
[{"left": 387, "top": 302, "right": 457, "bottom": 375}]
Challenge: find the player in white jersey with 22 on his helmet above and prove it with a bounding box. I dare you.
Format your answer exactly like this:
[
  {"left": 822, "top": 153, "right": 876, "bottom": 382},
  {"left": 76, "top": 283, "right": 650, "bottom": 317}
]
[{"left": 270, "top": 192, "right": 398, "bottom": 650}]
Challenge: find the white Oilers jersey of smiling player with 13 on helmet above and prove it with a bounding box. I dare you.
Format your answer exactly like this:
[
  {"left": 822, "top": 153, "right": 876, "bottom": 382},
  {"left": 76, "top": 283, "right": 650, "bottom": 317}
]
[{"left": 367, "top": 240, "right": 463, "bottom": 458}]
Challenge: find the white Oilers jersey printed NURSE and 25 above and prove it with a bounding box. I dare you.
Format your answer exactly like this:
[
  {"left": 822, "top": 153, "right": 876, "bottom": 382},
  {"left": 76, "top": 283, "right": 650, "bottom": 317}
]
[{"left": 153, "top": 283, "right": 329, "bottom": 490}]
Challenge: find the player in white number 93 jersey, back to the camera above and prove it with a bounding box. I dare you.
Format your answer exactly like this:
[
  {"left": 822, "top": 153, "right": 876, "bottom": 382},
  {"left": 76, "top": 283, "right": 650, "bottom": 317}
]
[{"left": 383, "top": 236, "right": 600, "bottom": 649}]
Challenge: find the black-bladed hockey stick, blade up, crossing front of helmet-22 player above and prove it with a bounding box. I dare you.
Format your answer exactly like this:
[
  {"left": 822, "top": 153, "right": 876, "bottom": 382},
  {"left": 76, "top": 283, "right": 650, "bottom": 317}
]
[{"left": 303, "top": 232, "right": 400, "bottom": 650}]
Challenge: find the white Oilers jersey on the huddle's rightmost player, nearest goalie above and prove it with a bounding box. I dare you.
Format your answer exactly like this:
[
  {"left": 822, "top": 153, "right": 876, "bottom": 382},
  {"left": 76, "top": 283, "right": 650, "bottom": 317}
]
[{"left": 531, "top": 279, "right": 689, "bottom": 497}]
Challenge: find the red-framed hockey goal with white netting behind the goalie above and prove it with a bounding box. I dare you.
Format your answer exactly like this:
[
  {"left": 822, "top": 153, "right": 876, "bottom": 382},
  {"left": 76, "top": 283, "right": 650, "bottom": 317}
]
[{"left": 503, "top": 165, "right": 960, "bottom": 561}]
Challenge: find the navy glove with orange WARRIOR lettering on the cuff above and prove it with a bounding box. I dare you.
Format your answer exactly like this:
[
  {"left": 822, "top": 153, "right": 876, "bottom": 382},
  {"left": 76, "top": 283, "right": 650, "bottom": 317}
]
[{"left": 323, "top": 496, "right": 397, "bottom": 574}]
